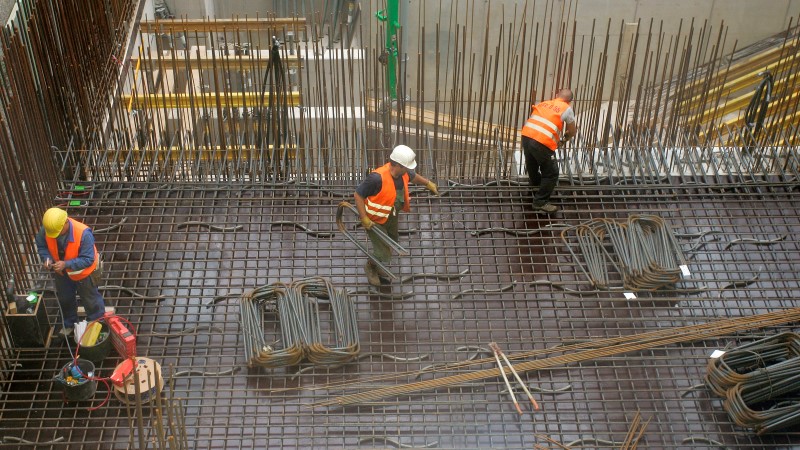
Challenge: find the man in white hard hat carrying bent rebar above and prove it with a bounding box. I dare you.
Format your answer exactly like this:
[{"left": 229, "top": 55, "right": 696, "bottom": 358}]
[{"left": 353, "top": 145, "right": 439, "bottom": 286}]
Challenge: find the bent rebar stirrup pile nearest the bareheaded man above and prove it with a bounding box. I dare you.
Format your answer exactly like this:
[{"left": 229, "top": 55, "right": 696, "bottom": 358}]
[{"left": 561, "top": 215, "right": 686, "bottom": 291}]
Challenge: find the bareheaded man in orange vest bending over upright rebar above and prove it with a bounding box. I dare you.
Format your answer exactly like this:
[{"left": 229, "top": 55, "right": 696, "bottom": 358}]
[{"left": 522, "top": 89, "right": 578, "bottom": 213}]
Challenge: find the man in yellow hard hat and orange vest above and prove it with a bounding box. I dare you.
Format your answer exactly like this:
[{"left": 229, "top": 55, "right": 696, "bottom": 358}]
[{"left": 36, "top": 208, "right": 106, "bottom": 338}]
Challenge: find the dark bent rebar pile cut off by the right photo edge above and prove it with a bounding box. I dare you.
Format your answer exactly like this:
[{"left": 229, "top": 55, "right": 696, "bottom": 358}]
[{"left": 705, "top": 333, "right": 800, "bottom": 434}]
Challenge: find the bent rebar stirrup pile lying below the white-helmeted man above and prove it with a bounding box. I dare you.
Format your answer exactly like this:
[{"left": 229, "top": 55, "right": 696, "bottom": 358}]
[{"left": 240, "top": 277, "right": 360, "bottom": 368}]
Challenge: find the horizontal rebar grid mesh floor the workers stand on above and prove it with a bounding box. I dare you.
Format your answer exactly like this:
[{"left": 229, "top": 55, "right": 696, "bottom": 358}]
[{"left": 0, "top": 184, "right": 800, "bottom": 449}]
